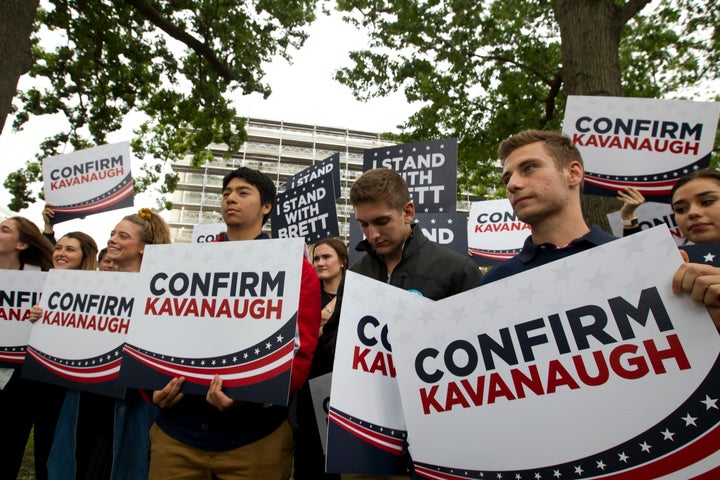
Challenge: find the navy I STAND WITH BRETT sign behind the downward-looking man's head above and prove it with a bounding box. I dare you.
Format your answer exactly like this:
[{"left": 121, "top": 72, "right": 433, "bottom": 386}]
[{"left": 363, "top": 138, "right": 457, "bottom": 213}]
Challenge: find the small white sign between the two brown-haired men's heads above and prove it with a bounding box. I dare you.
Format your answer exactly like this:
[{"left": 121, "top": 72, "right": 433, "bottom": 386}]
[{"left": 467, "top": 198, "right": 531, "bottom": 265}]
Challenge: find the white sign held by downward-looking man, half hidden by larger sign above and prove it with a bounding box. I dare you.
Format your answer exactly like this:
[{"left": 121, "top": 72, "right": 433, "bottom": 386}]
[{"left": 327, "top": 272, "right": 432, "bottom": 474}]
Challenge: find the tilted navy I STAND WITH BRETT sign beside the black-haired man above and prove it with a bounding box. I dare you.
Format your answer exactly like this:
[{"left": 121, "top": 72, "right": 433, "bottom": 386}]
[{"left": 270, "top": 172, "right": 340, "bottom": 244}]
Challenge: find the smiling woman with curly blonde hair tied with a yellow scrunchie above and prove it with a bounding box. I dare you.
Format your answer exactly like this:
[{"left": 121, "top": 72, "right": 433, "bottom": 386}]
[{"left": 48, "top": 208, "right": 170, "bottom": 480}]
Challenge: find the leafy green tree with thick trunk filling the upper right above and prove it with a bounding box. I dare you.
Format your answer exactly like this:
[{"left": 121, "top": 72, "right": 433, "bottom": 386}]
[{"left": 336, "top": 0, "right": 720, "bottom": 204}]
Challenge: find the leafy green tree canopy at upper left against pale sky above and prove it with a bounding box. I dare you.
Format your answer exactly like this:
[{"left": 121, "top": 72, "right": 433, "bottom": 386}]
[{"left": 0, "top": 0, "right": 316, "bottom": 210}]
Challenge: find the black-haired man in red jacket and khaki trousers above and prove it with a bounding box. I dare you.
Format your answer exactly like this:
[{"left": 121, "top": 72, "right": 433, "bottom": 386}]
[{"left": 150, "top": 167, "right": 320, "bottom": 480}]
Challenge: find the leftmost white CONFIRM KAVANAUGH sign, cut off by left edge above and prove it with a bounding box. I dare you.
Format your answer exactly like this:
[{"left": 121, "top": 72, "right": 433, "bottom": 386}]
[{"left": 0, "top": 270, "right": 47, "bottom": 367}]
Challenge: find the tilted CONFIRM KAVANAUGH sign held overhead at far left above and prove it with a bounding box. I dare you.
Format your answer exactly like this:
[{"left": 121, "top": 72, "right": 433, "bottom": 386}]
[{"left": 43, "top": 142, "right": 134, "bottom": 223}]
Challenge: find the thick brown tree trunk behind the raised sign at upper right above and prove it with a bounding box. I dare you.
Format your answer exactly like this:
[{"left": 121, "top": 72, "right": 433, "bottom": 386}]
[{"left": 554, "top": 0, "right": 640, "bottom": 232}]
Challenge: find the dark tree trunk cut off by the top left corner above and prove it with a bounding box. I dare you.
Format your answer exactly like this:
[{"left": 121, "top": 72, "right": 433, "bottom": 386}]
[{"left": 0, "top": 0, "right": 39, "bottom": 133}]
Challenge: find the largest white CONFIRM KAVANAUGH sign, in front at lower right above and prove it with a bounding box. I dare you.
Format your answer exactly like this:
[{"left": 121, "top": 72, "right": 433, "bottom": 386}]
[{"left": 386, "top": 227, "right": 720, "bottom": 480}]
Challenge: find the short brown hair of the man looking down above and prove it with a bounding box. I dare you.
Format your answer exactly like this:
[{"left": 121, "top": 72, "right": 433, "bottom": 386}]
[{"left": 350, "top": 168, "right": 410, "bottom": 210}]
